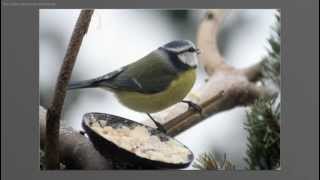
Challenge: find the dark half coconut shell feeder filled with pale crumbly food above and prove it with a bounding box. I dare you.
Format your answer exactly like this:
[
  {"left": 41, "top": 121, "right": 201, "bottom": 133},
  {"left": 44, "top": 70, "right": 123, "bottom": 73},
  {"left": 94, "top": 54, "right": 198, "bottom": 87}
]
[{"left": 82, "top": 112, "right": 194, "bottom": 169}]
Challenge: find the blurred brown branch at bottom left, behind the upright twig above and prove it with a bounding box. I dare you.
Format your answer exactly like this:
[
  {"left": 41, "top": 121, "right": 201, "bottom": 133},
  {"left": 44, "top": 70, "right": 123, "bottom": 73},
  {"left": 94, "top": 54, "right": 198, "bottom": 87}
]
[{"left": 39, "top": 106, "right": 112, "bottom": 170}]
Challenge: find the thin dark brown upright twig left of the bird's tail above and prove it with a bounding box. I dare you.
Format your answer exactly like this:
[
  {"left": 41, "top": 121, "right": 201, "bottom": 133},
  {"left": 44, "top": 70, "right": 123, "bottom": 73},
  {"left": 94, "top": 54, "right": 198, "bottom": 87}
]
[{"left": 45, "top": 10, "right": 93, "bottom": 169}]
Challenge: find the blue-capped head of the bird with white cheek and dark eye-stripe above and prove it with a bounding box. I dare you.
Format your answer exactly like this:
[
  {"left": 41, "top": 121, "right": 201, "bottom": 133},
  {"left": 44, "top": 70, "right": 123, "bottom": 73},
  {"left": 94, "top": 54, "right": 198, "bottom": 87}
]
[{"left": 160, "top": 40, "right": 200, "bottom": 68}]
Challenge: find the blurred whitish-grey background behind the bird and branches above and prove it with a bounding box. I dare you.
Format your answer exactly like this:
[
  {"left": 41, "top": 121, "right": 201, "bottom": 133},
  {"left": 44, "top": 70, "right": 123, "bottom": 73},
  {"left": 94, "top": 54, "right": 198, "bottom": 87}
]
[{"left": 39, "top": 9, "right": 276, "bottom": 169}]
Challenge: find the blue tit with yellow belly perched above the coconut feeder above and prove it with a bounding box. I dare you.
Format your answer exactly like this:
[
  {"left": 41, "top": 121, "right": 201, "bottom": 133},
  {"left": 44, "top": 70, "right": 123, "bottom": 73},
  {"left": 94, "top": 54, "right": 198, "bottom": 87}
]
[{"left": 68, "top": 40, "right": 201, "bottom": 132}]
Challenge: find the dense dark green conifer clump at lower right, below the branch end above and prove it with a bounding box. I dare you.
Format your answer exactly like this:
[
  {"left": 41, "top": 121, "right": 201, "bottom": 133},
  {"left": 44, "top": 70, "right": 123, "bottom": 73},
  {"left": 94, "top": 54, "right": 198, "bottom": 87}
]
[{"left": 245, "top": 97, "right": 280, "bottom": 170}]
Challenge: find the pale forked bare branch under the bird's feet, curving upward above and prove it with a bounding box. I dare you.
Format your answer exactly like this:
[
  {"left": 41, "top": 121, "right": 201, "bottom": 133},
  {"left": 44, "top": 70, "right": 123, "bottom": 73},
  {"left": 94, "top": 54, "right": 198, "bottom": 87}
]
[{"left": 145, "top": 10, "right": 269, "bottom": 136}]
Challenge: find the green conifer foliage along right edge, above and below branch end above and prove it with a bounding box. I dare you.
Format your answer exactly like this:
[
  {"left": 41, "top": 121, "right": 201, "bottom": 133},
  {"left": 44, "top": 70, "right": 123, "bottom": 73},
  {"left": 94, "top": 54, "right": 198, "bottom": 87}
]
[{"left": 245, "top": 10, "right": 280, "bottom": 170}]
